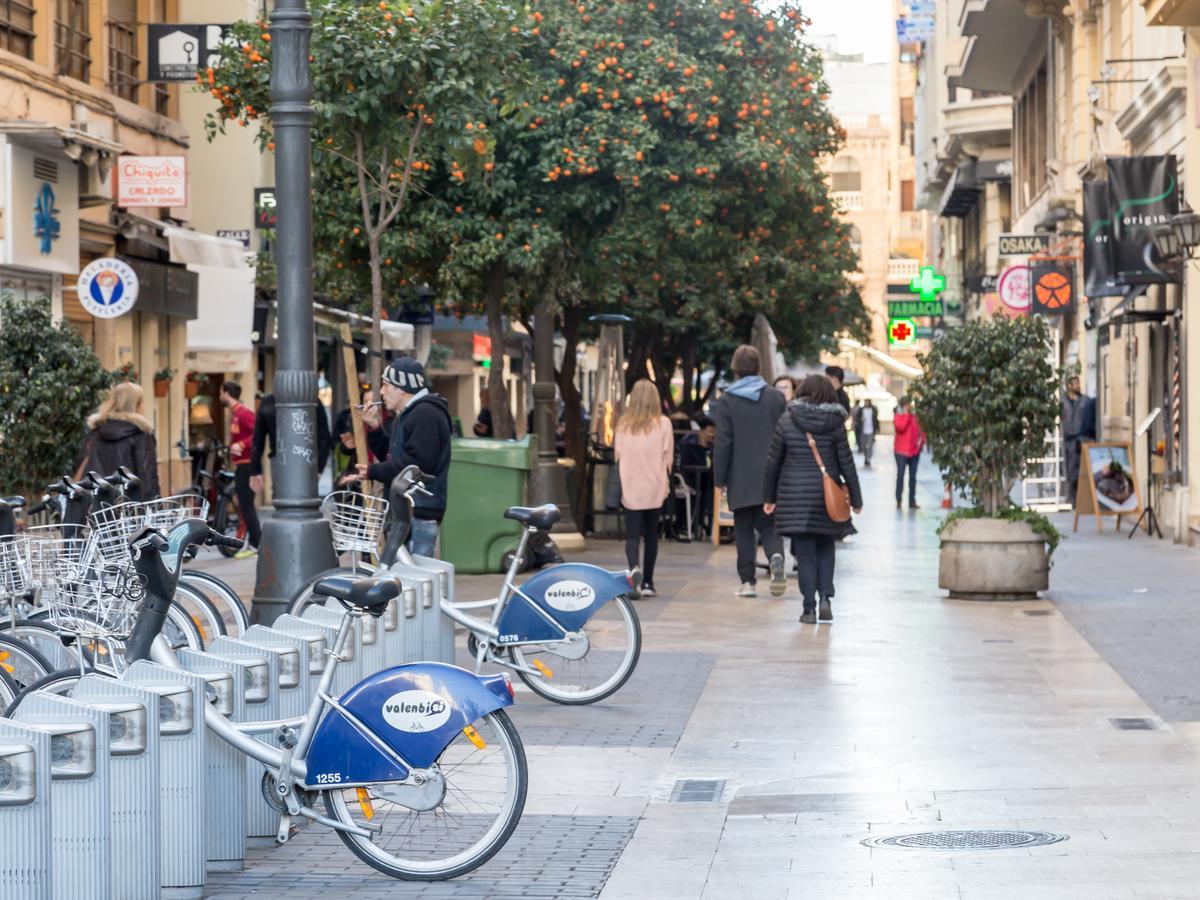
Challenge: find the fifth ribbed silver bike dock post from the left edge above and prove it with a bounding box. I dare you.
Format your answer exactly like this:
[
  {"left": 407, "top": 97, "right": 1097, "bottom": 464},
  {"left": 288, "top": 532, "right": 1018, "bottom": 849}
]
[{"left": 176, "top": 649, "right": 247, "bottom": 872}]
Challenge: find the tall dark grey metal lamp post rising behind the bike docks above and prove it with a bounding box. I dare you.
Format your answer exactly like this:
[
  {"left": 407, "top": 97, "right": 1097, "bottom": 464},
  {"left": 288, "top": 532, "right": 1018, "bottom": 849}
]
[{"left": 253, "top": 0, "right": 337, "bottom": 624}]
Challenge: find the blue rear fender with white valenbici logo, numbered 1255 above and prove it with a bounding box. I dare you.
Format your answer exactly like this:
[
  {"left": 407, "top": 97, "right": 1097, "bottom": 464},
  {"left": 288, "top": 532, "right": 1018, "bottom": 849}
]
[{"left": 306, "top": 662, "right": 512, "bottom": 788}]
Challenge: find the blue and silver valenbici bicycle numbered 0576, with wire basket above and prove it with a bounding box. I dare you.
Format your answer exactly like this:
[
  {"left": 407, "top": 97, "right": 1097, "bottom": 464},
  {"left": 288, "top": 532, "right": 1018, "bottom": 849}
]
[{"left": 288, "top": 466, "right": 642, "bottom": 706}]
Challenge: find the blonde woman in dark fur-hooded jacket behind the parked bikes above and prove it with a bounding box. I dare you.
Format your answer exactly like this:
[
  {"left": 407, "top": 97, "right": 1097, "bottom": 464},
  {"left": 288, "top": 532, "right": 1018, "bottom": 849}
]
[{"left": 76, "top": 382, "right": 158, "bottom": 500}]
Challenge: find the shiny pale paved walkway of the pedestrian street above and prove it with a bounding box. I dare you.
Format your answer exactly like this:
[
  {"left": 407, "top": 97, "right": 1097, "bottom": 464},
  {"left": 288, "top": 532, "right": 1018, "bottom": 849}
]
[{"left": 201, "top": 458, "right": 1200, "bottom": 900}]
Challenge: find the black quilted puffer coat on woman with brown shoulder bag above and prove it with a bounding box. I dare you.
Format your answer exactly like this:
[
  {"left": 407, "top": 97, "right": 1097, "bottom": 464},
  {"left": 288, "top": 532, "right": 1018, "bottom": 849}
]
[{"left": 762, "top": 401, "right": 863, "bottom": 535}]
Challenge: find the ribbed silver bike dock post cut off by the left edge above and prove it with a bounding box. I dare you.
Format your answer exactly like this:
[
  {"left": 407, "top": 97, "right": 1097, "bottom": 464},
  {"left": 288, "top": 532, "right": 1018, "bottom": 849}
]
[{"left": 0, "top": 719, "right": 54, "bottom": 900}]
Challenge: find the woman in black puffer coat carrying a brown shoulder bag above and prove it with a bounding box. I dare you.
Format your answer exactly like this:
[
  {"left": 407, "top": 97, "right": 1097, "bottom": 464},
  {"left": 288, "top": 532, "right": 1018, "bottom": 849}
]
[{"left": 763, "top": 374, "right": 863, "bottom": 624}]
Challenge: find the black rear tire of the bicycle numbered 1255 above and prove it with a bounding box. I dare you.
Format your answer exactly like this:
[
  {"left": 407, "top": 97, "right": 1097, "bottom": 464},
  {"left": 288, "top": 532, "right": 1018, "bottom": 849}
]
[{"left": 323, "top": 709, "right": 529, "bottom": 881}]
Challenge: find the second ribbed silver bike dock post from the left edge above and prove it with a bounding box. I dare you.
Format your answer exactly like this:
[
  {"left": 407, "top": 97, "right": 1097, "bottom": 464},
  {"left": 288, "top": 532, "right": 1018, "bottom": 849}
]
[{"left": 16, "top": 691, "right": 113, "bottom": 900}]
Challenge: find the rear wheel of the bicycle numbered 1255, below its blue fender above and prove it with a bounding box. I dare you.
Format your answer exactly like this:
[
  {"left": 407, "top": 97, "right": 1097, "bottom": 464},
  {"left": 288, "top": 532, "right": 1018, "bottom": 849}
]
[{"left": 325, "top": 709, "right": 529, "bottom": 881}]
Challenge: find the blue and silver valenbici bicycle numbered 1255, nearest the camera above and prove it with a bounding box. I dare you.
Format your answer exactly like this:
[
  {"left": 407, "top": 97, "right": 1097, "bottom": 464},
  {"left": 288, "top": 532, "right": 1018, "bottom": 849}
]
[{"left": 125, "top": 518, "right": 528, "bottom": 881}]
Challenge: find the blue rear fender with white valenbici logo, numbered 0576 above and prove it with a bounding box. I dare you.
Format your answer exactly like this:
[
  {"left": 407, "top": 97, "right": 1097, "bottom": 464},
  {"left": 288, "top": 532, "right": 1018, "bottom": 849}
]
[{"left": 497, "top": 563, "right": 630, "bottom": 643}]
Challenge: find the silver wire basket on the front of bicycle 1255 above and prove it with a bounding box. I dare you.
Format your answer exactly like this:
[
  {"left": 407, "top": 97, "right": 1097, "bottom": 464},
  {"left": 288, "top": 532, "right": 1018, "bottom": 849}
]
[{"left": 42, "top": 559, "right": 146, "bottom": 641}]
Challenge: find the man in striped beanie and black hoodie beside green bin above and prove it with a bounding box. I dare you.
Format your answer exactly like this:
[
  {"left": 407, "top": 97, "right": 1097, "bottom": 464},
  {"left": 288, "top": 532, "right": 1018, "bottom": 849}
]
[{"left": 358, "top": 356, "right": 450, "bottom": 557}]
